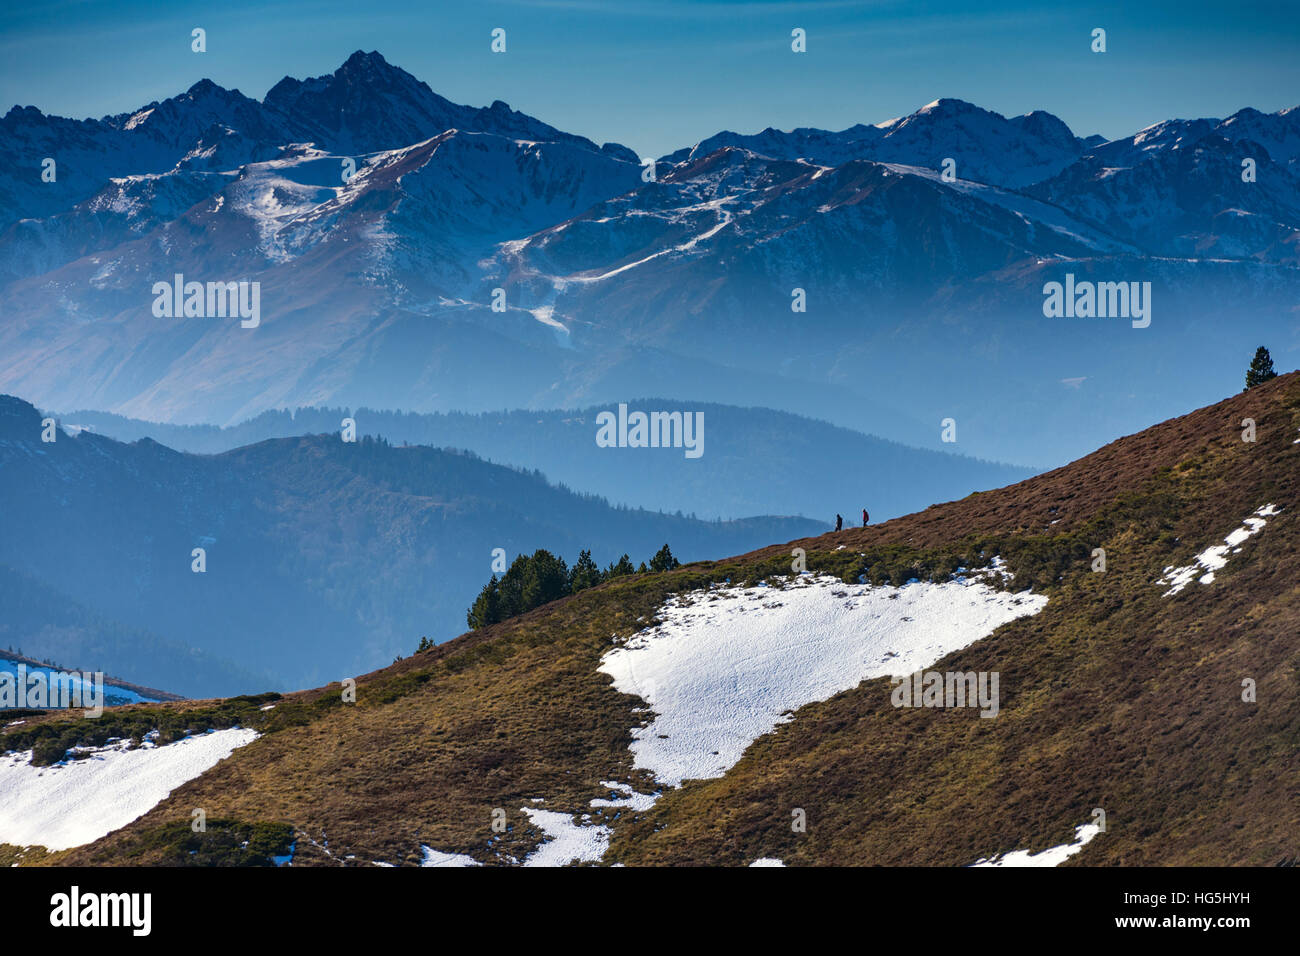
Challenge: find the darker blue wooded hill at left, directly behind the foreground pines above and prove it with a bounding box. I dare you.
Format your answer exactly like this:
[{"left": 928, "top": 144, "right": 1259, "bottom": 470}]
[{"left": 0, "top": 397, "right": 826, "bottom": 693}]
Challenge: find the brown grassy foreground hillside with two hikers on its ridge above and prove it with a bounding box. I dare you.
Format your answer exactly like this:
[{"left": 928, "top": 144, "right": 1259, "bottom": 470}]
[{"left": 12, "top": 373, "right": 1300, "bottom": 865}]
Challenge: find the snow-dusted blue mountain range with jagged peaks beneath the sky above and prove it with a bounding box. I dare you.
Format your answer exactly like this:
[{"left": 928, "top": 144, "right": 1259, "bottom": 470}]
[{"left": 0, "top": 52, "right": 1300, "bottom": 463}]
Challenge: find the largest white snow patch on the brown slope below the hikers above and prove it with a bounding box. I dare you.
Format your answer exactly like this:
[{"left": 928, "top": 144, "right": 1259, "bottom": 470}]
[{"left": 599, "top": 575, "right": 1047, "bottom": 787}]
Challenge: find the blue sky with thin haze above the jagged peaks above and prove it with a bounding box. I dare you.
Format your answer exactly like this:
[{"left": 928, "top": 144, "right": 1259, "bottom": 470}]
[{"left": 0, "top": 0, "right": 1300, "bottom": 155}]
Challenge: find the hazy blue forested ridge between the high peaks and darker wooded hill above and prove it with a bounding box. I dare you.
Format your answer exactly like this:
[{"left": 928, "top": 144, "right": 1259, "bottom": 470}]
[{"left": 60, "top": 398, "right": 1030, "bottom": 523}]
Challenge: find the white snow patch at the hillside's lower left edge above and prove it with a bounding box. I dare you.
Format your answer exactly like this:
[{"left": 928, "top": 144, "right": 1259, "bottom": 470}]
[{"left": 0, "top": 727, "right": 257, "bottom": 849}]
